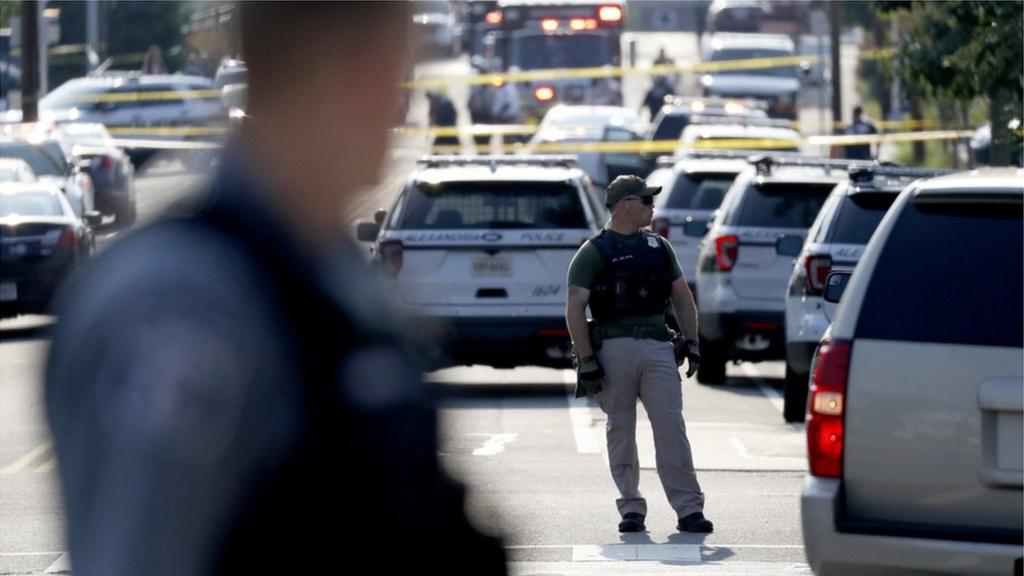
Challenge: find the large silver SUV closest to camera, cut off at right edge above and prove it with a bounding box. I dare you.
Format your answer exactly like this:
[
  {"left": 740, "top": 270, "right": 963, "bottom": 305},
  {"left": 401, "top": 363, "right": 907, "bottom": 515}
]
[{"left": 801, "top": 169, "right": 1024, "bottom": 576}]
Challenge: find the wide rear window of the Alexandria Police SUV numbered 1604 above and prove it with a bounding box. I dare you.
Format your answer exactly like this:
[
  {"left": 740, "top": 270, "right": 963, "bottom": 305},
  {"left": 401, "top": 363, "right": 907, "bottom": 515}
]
[{"left": 397, "top": 181, "right": 588, "bottom": 230}]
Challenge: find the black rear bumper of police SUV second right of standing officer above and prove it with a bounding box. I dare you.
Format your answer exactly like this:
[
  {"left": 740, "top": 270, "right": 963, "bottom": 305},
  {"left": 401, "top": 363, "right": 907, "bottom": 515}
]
[{"left": 699, "top": 311, "right": 785, "bottom": 362}]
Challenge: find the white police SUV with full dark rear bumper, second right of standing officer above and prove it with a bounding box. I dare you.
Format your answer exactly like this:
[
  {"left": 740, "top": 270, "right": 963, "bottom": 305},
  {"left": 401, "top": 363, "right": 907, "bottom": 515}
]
[{"left": 697, "top": 156, "right": 868, "bottom": 383}]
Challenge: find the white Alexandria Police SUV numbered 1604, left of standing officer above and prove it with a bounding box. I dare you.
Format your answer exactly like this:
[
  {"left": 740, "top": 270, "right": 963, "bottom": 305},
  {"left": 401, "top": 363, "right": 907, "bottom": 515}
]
[{"left": 357, "top": 156, "right": 606, "bottom": 368}]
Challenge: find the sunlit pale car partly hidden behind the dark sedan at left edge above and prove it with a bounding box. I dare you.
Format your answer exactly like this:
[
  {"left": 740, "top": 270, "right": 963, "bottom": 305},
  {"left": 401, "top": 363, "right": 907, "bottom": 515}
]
[{"left": 0, "top": 133, "right": 96, "bottom": 218}]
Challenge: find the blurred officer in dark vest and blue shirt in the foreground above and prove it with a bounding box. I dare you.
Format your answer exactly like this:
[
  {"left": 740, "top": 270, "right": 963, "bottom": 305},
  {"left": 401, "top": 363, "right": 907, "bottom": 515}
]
[{"left": 46, "top": 2, "right": 505, "bottom": 576}]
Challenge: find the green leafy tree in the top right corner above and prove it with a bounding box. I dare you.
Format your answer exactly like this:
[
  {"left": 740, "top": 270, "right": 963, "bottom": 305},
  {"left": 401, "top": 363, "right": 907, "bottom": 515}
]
[{"left": 879, "top": 0, "right": 1024, "bottom": 165}]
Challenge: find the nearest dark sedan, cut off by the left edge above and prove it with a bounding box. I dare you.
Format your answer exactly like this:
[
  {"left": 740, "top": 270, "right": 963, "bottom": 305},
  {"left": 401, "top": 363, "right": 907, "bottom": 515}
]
[{"left": 0, "top": 183, "right": 99, "bottom": 318}]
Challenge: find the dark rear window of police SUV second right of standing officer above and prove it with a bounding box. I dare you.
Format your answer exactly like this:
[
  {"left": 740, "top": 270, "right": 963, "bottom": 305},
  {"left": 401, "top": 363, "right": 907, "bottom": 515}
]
[{"left": 730, "top": 182, "right": 836, "bottom": 229}]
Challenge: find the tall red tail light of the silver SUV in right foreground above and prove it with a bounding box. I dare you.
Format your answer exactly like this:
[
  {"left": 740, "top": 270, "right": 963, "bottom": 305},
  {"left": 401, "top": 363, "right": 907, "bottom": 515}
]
[{"left": 807, "top": 339, "right": 853, "bottom": 478}]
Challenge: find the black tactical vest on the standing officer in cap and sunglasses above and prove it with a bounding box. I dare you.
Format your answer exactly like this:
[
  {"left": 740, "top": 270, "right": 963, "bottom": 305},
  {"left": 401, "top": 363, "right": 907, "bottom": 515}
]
[{"left": 590, "top": 226, "right": 673, "bottom": 325}]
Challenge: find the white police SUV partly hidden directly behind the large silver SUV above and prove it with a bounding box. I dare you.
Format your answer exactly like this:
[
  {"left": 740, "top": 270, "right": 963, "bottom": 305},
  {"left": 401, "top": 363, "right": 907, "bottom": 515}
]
[{"left": 779, "top": 166, "right": 950, "bottom": 422}]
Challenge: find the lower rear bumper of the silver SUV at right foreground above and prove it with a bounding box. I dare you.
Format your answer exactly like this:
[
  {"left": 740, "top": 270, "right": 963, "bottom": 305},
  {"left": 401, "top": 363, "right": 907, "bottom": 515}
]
[{"left": 801, "top": 476, "right": 1024, "bottom": 576}]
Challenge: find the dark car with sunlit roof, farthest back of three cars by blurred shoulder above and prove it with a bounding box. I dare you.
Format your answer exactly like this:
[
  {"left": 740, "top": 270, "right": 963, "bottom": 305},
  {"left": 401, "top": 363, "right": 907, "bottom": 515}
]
[{"left": 60, "top": 122, "right": 136, "bottom": 228}]
